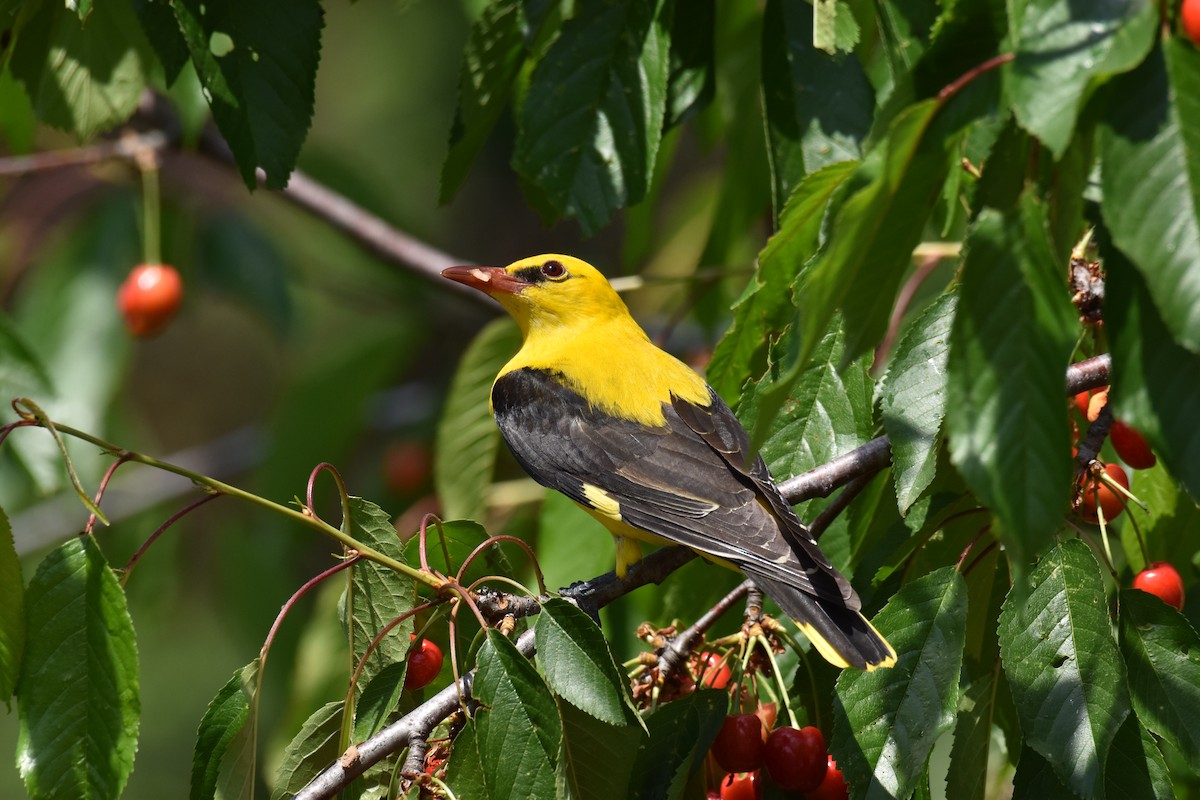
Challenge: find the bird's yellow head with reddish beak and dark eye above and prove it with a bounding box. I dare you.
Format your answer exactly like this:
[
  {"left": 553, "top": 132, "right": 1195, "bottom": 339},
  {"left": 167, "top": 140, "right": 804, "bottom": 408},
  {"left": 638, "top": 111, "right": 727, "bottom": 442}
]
[{"left": 442, "top": 253, "right": 629, "bottom": 335}]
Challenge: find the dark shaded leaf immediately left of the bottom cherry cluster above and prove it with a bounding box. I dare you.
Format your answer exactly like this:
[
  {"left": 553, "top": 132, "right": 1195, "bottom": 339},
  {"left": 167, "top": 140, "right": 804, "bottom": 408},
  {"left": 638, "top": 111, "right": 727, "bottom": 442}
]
[{"left": 629, "top": 690, "right": 730, "bottom": 800}]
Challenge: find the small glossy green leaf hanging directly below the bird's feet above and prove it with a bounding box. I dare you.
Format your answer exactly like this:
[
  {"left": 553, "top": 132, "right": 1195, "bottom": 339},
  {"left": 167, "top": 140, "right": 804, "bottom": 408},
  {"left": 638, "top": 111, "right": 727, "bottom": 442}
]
[{"left": 534, "top": 597, "right": 642, "bottom": 726}]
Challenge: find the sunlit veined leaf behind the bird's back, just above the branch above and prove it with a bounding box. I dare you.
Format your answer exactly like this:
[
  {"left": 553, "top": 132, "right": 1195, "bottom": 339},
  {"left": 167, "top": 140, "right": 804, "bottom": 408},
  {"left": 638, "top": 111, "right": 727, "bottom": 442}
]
[{"left": 738, "top": 320, "right": 872, "bottom": 516}]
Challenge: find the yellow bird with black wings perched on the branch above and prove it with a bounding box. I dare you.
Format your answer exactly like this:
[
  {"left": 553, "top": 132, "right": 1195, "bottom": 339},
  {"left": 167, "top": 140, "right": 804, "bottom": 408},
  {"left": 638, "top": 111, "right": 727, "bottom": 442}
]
[{"left": 443, "top": 254, "right": 895, "bottom": 669}]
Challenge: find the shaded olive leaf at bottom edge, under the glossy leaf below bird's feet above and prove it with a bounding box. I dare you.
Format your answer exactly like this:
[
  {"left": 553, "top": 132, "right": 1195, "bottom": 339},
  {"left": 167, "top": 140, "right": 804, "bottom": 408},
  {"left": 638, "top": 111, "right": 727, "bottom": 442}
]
[{"left": 557, "top": 700, "right": 646, "bottom": 800}]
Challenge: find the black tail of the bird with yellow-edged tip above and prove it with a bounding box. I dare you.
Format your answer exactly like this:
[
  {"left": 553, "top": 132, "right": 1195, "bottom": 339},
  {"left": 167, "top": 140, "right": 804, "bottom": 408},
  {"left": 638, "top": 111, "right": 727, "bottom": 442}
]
[{"left": 742, "top": 565, "right": 896, "bottom": 670}]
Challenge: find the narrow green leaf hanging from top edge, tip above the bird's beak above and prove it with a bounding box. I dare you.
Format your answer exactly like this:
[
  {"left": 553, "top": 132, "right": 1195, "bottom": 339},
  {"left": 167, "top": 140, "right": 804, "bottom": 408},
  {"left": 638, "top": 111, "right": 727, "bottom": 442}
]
[{"left": 438, "top": 0, "right": 528, "bottom": 203}]
